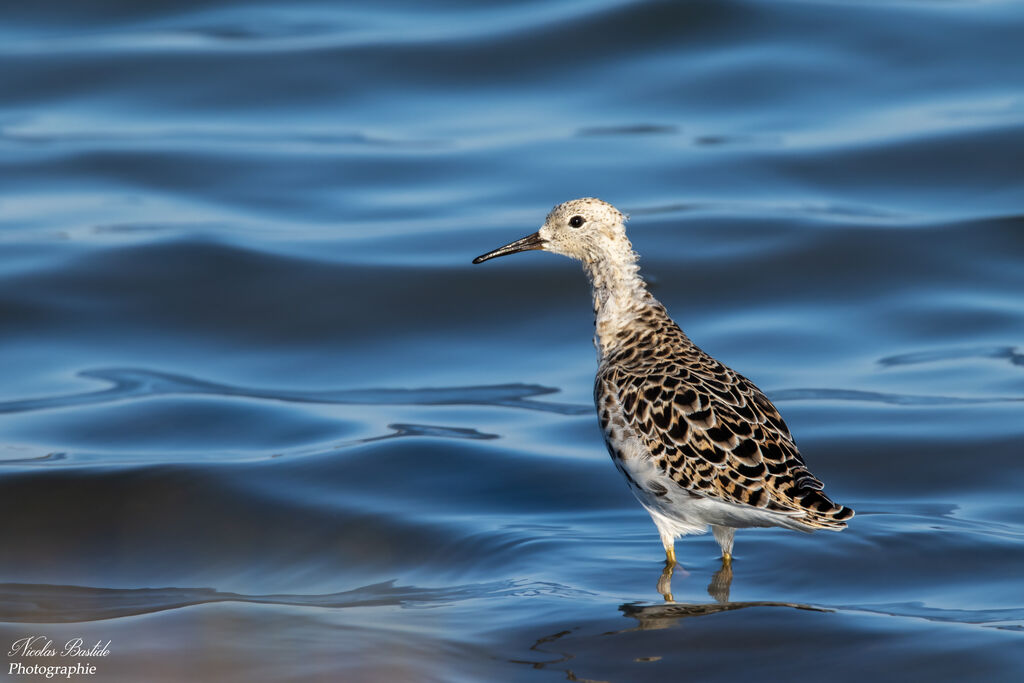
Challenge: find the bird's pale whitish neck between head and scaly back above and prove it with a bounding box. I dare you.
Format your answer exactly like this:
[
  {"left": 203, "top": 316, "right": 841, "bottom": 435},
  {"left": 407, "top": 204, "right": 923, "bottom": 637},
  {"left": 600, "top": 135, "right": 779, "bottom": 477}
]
[{"left": 584, "top": 249, "right": 657, "bottom": 358}]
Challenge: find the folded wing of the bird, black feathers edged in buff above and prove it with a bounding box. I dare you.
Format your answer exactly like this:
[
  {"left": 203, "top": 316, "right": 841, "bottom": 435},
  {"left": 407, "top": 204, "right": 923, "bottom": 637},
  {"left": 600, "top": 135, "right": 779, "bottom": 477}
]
[{"left": 595, "top": 342, "right": 853, "bottom": 529}]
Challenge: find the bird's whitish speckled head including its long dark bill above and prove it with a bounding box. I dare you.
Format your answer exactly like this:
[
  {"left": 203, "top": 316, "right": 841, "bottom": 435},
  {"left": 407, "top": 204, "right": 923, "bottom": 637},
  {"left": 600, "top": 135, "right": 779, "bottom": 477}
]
[{"left": 473, "top": 197, "right": 636, "bottom": 263}]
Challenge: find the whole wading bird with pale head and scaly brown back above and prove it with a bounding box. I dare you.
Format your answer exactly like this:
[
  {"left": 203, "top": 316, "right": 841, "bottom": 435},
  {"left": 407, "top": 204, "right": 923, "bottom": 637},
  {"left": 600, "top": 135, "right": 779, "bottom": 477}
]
[{"left": 474, "top": 198, "right": 853, "bottom": 565}]
